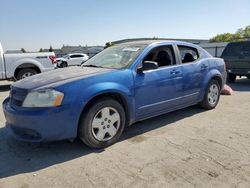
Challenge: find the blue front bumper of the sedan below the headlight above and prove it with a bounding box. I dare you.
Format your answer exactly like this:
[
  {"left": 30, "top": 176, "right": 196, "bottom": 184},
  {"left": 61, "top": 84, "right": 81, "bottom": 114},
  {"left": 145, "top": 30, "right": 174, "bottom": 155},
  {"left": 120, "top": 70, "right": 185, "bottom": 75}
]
[{"left": 3, "top": 98, "right": 78, "bottom": 142}]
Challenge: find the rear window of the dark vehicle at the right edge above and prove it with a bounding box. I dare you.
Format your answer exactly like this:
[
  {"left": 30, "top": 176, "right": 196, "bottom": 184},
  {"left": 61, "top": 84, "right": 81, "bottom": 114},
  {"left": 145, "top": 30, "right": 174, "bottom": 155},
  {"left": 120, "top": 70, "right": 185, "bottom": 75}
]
[{"left": 221, "top": 42, "right": 250, "bottom": 57}]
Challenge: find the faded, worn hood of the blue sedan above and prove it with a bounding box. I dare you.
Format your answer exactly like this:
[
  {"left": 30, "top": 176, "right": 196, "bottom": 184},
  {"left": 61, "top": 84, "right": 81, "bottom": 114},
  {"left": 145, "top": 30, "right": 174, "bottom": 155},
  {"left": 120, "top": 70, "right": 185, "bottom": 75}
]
[{"left": 12, "top": 67, "right": 115, "bottom": 90}]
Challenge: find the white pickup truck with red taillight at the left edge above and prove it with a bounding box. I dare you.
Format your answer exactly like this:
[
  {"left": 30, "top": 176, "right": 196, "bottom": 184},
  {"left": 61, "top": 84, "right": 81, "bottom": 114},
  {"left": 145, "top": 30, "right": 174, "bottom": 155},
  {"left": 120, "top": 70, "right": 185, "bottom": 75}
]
[{"left": 0, "top": 43, "right": 56, "bottom": 80}]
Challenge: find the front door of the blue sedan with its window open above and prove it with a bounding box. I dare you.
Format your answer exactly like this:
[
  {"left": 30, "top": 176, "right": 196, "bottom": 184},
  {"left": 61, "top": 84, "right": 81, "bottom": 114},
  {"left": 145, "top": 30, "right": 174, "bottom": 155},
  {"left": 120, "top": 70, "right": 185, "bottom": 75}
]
[{"left": 135, "top": 45, "right": 183, "bottom": 120}]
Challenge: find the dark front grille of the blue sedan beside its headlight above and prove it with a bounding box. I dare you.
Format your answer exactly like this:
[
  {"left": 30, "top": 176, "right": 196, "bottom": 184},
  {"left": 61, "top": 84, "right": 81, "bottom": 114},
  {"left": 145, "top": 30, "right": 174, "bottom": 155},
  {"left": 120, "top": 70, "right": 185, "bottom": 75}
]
[{"left": 10, "top": 86, "right": 28, "bottom": 106}]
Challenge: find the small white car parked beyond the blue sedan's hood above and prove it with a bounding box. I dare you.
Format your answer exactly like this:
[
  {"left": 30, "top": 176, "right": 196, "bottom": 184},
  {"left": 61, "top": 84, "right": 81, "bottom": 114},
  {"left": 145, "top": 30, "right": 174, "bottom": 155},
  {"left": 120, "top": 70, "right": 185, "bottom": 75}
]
[{"left": 56, "top": 53, "right": 89, "bottom": 67}]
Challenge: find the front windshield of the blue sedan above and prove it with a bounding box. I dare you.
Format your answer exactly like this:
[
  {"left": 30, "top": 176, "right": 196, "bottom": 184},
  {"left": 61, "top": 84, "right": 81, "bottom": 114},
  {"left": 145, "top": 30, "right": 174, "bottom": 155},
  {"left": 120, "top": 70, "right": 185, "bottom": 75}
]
[{"left": 82, "top": 45, "right": 146, "bottom": 69}]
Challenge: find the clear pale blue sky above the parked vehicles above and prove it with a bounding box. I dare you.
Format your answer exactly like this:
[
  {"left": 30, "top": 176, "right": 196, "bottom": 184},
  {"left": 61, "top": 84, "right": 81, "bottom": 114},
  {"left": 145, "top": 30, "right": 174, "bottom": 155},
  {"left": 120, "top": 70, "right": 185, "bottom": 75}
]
[{"left": 0, "top": 0, "right": 250, "bottom": 50}]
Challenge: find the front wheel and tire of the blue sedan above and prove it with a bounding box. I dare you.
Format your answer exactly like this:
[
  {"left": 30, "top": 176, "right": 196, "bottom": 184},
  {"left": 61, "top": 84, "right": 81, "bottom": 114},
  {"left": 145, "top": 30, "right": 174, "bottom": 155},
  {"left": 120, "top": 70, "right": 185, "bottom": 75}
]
[{"left": 78, "top": 98, "right": 126, "bottom": 148}]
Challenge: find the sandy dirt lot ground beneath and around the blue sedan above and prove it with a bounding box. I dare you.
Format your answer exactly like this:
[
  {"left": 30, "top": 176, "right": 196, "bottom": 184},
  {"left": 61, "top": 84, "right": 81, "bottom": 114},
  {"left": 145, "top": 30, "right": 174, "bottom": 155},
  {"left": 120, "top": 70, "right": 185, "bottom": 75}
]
[{"left": 0, "top": 79, "right": 250, "bottom": 188}]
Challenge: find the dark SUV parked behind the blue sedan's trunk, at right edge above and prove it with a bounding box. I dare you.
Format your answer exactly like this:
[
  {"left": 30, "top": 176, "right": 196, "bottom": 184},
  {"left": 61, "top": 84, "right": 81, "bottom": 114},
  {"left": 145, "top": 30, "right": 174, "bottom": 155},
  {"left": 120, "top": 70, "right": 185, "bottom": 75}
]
[{"left": 221, "top": 41, "right": 250, "bottom": 82}]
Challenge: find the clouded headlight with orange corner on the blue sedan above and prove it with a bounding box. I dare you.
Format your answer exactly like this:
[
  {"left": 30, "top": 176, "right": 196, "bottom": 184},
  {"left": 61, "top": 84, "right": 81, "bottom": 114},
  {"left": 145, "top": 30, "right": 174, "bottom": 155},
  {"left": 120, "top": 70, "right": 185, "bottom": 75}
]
[{"left": 23, "top": 89, "right": 64, "bottom": 107}]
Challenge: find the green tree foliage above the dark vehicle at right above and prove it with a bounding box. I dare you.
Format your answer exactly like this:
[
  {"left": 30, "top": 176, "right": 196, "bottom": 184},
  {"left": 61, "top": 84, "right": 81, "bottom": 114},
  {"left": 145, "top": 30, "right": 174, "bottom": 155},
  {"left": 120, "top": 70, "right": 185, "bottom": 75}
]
[{"left": 210, "top": 26, "right": 250, "bottom": 42}]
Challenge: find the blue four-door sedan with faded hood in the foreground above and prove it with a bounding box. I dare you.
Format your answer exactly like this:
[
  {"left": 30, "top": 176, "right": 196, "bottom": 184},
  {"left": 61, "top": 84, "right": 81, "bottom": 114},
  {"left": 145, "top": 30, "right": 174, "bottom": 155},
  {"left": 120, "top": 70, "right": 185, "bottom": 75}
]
[{"left": 3, "top": 41, "right": 226, "bottom": 148}]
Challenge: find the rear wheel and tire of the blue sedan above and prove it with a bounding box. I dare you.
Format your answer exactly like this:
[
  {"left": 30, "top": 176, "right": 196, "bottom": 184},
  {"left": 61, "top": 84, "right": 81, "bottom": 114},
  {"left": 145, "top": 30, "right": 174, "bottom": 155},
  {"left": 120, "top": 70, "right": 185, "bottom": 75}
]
[{"left": 200, "top": 80, "right": 221, "bottom": 110}]
